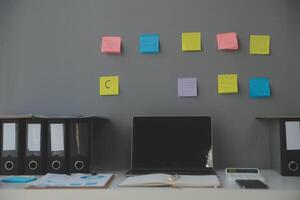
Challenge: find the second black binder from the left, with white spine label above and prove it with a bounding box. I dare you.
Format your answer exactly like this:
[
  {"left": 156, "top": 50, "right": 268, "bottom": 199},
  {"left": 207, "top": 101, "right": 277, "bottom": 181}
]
[{"left": 24, "top": 119, "right": 47, "bottom": 175}]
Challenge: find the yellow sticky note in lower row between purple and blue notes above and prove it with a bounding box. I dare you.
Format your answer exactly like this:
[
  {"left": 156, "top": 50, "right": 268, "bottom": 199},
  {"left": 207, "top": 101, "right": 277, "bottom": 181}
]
[{"left": 218, "top": 74, "right": 238, "bottom": 94}]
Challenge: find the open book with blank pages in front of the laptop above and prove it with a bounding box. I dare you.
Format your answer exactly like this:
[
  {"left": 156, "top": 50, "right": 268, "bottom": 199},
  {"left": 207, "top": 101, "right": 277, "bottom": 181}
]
[{"left": 119, "top": 174, "right": 220, "bottom": 187}]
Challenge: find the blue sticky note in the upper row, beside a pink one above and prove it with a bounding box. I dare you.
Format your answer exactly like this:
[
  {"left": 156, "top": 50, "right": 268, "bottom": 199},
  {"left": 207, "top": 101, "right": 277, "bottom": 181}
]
[{"left": 140, "top": 34, "right": 159, "bottom": 54}]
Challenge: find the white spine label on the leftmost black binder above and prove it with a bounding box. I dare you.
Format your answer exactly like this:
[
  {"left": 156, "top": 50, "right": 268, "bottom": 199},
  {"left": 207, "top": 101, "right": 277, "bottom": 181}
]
[{"left": 2, "top": 123, "right": 16, "bottom": 151}]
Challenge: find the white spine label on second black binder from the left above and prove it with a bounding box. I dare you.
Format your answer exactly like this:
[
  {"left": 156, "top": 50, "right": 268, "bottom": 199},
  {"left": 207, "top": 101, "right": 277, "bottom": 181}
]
[{"left": 27, "top": 124, "right": 41, "bottom": 151}]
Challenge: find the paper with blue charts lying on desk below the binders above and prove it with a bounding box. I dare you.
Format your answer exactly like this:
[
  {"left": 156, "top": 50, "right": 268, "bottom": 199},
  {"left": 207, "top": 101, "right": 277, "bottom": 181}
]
[{"left": 28, "top": 174, "right": 113, "bottom": 188}]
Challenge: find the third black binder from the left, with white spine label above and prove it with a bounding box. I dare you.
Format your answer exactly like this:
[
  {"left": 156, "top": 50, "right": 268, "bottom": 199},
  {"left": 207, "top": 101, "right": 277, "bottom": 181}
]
[{"left": 47, "top": 119, "right": 67, "bottom": 174}]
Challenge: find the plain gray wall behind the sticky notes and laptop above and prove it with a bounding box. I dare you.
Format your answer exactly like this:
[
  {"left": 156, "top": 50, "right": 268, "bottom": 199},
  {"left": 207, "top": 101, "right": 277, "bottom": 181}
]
[{"left": 0, "top": 0, "right": 300, "bottom": 169}]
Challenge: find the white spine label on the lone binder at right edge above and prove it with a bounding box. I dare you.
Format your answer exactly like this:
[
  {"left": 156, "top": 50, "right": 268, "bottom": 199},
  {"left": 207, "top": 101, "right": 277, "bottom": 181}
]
[{"left": 285, "top": 121, "right": 300, "bottom": 150}]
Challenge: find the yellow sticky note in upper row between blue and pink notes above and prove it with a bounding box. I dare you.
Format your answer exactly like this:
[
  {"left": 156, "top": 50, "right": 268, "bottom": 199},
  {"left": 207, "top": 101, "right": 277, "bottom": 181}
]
[{"left": 181, "top": 32, "right": 201, "bottom": 51}]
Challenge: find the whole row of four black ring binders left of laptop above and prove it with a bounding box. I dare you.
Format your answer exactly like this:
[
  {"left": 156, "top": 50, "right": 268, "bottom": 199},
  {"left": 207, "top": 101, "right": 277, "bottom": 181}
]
[{"left": 0, "top": 115, "right": 107, "bottom": 175}]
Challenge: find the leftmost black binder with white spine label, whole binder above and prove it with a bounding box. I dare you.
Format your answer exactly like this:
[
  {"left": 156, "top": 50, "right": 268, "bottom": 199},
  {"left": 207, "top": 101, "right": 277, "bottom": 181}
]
[{"left": 0, "top": 119, "right": 24, "bottom": 175}]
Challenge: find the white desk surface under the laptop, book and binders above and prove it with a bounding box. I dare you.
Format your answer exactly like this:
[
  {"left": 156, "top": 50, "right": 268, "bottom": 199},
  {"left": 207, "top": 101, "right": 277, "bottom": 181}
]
[{"left": 0, "top": 170, "right": 300, "bottom": 200}]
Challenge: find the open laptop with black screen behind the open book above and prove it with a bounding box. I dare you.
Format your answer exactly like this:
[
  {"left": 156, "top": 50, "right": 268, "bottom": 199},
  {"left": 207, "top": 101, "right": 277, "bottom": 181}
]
[{"left": 127, "top": 116, "right": 215, "bottom": 175}]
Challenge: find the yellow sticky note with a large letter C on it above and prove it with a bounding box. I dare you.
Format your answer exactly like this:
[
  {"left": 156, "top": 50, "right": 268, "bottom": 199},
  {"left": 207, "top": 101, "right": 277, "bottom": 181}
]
[{"left": 99, "top": 76, "right": 119, "bottom": 96}]
